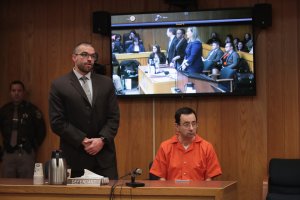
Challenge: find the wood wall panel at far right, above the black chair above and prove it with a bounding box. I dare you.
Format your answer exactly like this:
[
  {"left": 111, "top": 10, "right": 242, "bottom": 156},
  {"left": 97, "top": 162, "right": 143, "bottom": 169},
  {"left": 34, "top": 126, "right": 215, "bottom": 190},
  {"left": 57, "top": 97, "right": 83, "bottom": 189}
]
[{"left": 267, "top": 1, "right": 299, "bottom": 158}]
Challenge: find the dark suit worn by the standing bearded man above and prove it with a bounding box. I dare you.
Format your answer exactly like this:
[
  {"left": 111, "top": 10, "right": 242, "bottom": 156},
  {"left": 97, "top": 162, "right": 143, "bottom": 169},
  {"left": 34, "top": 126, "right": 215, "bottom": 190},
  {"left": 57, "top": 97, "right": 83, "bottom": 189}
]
[{"left": 49, "top": 71, "right": 120, "bottom": 179}]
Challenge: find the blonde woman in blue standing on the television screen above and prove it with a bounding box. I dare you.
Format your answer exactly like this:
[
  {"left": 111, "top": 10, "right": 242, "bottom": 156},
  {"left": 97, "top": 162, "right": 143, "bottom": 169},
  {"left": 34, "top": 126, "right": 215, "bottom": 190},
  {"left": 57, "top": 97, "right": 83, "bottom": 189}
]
[{"left": 180, "top": 27, "right": 204, "bottom": 73}]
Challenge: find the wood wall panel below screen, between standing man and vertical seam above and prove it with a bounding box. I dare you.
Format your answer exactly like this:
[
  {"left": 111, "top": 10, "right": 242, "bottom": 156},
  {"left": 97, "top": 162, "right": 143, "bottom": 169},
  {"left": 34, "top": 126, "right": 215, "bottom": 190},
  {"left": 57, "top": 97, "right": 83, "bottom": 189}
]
[{"left": 116, "top": 99, "right": 153, "bottom": 179}]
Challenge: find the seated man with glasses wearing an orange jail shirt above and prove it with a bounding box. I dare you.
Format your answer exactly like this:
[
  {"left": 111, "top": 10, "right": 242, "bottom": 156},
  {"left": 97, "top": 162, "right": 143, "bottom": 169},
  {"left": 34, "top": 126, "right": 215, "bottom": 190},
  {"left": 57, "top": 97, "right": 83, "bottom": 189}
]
[{"left": 150, "top": 107, "right": 222, "bottom": 181}]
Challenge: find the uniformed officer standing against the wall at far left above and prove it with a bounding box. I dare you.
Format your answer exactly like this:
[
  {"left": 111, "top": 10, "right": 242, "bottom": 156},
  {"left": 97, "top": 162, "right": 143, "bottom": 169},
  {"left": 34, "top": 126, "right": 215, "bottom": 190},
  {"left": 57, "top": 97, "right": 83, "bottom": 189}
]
[{"left": 0, "top": 80, "right": 46, "bottom": 178}]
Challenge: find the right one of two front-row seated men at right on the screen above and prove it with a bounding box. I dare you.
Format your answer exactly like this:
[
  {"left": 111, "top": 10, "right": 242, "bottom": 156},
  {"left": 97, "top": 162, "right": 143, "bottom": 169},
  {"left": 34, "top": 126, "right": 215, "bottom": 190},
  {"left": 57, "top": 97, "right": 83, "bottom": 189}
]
[{"left": 219, "top": 42, "right": 240, "bottom": 70}]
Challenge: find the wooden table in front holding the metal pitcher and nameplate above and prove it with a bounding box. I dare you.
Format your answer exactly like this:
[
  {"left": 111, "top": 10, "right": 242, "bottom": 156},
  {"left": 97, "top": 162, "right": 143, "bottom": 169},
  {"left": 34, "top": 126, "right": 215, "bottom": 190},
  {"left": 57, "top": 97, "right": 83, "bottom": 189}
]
[{"left": 0, "top": 179, "right": 237, "bottom": 200}]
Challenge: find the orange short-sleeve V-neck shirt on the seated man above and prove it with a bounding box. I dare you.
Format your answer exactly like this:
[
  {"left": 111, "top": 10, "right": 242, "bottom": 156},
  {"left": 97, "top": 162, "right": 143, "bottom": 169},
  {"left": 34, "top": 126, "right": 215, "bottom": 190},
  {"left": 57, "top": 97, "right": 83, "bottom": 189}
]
[{"left": 150, "top": 135, "right": 222, "bottom": 180}]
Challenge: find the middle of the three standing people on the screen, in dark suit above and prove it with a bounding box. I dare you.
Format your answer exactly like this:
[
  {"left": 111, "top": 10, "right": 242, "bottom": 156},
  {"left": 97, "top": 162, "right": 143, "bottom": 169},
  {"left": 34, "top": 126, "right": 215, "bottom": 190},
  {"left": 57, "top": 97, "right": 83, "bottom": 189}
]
[{"left": 170, "top": 28, "right": 187, "bottom": 69}]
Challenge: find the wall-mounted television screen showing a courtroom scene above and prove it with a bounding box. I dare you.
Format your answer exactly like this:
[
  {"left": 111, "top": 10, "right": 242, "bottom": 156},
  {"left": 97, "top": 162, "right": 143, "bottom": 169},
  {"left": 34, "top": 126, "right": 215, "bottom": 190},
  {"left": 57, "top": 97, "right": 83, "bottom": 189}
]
[{"left": 111, "top": 8, "right": 256, "bottom": 96}]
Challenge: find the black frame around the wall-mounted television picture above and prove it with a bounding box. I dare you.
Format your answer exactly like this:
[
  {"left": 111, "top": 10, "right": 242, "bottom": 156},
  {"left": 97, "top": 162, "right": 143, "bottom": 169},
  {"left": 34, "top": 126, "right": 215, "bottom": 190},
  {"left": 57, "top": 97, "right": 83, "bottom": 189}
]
[{"left": 109, "top": 7, "right": 257, "bottom": 98}]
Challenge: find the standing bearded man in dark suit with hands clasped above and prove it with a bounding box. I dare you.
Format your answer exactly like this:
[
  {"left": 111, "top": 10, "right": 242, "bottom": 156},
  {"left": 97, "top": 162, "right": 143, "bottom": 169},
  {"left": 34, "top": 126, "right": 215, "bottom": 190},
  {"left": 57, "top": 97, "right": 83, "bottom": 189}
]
[{"left": 49, "top": 43, "right": 120, "bottom": 179}]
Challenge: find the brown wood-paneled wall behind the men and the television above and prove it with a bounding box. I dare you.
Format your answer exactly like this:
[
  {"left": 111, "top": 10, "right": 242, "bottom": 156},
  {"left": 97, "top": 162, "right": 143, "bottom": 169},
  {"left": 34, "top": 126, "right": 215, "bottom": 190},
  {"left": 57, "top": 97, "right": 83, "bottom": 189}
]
[{"left": 0, "top": 0, "right": 300, "bottom": 200}]
